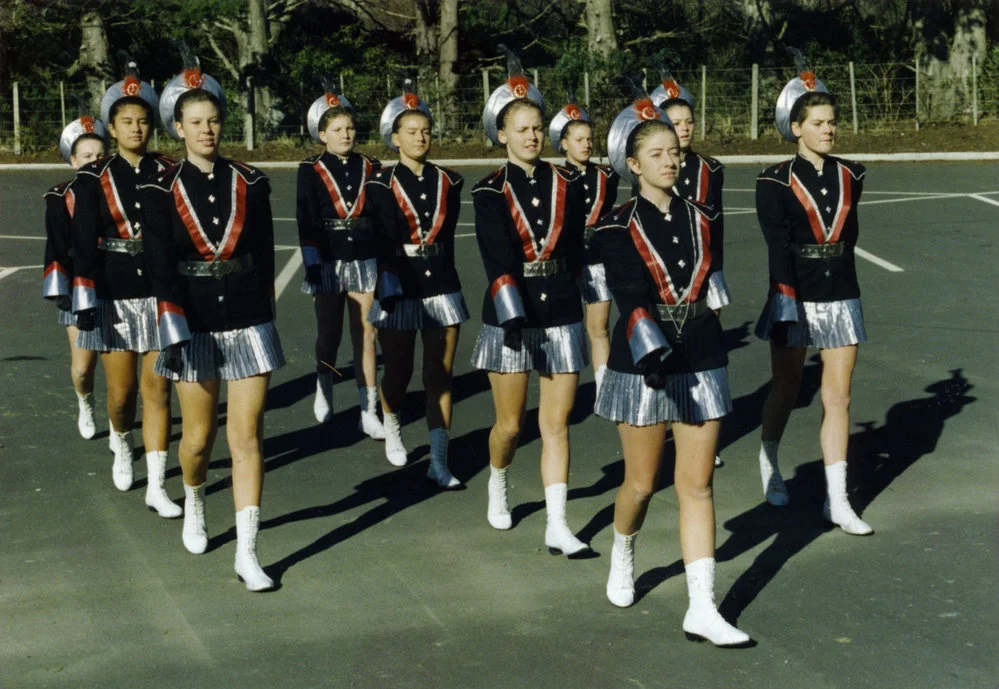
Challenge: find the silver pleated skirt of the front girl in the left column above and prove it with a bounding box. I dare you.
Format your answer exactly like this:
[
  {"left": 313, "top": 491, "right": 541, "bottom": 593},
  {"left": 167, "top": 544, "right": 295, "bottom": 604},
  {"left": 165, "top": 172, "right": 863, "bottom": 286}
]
[{"left": 153, "top": 321, "right": 284, "bottom": 383}]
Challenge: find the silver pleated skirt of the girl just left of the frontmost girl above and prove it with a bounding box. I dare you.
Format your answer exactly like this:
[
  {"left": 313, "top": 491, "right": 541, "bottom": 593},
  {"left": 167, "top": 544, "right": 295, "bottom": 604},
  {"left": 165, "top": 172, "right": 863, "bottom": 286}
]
[{"left": 472, "top": 323, "right": 589, "bottom": 373}]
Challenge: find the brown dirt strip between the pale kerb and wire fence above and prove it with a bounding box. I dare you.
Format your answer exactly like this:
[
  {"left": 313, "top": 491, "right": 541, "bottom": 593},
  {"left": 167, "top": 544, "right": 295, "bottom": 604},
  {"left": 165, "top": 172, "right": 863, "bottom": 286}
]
[{"left": 0, "top": 120, "right": 999, "bottom": 163}]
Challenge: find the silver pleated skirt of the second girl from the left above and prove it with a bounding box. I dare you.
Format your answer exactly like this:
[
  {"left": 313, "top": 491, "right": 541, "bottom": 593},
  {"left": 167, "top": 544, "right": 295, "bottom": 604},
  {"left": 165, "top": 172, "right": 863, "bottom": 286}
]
[{"left": 76, "top": 297, "right": 160, "bottom": 354}]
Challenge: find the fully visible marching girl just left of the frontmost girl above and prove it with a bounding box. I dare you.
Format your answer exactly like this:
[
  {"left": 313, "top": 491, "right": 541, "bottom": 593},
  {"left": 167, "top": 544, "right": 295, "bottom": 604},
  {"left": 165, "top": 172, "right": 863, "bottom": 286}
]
[{"left": 472, "top": 53, "right": 589, "bottom": 556}]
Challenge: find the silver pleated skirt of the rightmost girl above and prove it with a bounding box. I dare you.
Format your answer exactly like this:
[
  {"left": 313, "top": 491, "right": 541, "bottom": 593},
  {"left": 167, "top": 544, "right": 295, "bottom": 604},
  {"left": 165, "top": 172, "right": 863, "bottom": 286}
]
[{"left": 756, "top": 299, "right": 867, "bottom": 349}]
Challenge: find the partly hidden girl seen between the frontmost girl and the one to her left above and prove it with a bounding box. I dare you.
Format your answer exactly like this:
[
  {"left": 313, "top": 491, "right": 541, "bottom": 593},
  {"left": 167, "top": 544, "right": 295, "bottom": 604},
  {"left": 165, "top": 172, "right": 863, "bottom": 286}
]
[{"left": 548, "top": 92, "right": 619, "bottom": 388}]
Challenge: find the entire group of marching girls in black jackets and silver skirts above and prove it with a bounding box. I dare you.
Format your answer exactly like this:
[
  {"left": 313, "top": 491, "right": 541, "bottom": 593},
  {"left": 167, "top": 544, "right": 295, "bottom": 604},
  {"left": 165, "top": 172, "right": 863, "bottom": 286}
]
[{"left": 43, "top": 45, "right": 873, "bottom": 646}]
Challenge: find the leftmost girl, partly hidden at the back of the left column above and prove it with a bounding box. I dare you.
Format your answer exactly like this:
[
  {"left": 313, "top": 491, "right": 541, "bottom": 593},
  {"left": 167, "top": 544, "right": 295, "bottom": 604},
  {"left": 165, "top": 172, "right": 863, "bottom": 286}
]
[{"left": 42, "top": 114, "right": 107, "bottom": 440}]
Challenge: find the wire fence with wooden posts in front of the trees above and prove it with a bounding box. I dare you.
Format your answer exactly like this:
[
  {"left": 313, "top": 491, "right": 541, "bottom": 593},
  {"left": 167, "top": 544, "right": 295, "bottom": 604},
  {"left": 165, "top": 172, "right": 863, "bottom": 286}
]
[{"left": 0, "top": 63, "right": 999, "bottom": 152}]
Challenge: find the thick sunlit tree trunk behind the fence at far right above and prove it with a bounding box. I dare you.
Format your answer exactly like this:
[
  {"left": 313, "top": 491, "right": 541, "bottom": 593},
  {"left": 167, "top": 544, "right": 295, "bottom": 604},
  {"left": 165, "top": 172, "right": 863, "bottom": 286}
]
[{"left": 913, "top": 0, "right": 987, "bottom": 119}]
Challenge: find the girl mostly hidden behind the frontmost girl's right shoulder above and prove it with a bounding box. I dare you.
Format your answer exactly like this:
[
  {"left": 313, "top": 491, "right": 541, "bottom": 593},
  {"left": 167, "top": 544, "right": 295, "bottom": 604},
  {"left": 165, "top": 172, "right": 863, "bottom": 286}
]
[{"left": 649, "top": 72, "right": 732, "bottom": 467}]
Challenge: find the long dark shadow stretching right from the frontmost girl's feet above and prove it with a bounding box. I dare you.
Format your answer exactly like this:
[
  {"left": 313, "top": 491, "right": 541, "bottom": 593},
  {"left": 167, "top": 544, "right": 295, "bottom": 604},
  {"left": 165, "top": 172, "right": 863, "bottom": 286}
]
[{"left": 636, "top": 368, "right": 977, "bottom": 623}]
